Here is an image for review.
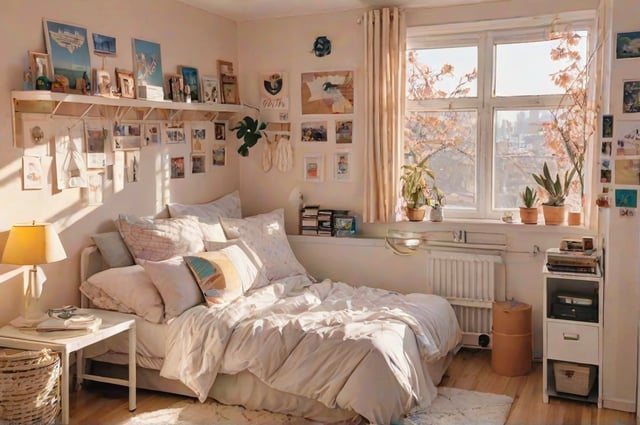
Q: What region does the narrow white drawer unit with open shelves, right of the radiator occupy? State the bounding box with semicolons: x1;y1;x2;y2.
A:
542;252;604;407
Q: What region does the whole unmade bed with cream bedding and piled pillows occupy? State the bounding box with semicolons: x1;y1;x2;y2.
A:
80;193;461;424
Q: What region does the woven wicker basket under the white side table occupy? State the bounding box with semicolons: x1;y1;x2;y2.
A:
0;349;60;425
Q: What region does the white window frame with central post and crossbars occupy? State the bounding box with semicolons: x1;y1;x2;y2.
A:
403;11;596;219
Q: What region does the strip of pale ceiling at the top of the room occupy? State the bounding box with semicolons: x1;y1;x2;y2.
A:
179;0;496;22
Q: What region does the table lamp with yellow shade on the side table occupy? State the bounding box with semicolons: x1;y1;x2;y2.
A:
2;221;67;320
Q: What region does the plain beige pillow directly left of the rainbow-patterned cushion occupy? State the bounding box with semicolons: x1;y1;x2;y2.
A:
141;256;203;321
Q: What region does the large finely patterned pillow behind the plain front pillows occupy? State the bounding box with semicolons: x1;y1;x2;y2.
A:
116;214;204;261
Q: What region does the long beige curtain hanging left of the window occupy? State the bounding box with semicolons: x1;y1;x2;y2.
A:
363;8;406;223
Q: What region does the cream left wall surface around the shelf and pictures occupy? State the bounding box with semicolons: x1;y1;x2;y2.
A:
0;0;238;324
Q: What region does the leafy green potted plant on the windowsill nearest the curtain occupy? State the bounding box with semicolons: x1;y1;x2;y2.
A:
400;158;434;221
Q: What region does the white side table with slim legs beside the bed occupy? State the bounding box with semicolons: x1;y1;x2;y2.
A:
0;309;136;425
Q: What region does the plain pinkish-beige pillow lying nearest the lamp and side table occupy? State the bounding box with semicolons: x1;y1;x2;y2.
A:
80;264;164;323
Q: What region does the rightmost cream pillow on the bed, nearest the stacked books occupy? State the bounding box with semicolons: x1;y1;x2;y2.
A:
220;208;307;281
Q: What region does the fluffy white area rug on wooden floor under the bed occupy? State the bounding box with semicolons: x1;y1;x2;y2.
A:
127;387;513;425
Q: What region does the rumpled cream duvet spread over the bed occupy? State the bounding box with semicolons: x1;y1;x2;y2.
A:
160;276;461;424
